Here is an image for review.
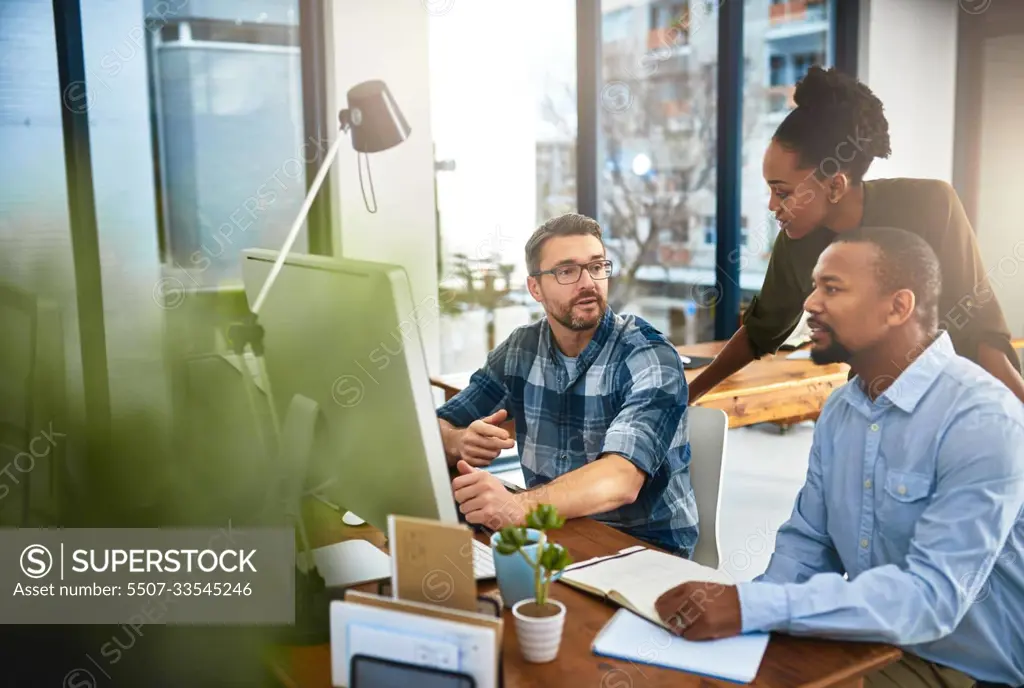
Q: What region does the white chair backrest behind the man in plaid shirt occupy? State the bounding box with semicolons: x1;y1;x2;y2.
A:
687;406;729;568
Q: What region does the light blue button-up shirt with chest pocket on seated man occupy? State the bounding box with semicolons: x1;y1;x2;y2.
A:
737;332;1024;686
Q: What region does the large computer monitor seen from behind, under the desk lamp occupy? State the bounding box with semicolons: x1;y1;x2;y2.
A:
243;249;459;532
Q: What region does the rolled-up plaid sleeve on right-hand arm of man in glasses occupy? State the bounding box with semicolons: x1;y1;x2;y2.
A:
601;344;689;476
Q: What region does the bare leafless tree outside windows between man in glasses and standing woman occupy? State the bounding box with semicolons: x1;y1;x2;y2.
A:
542;38;766;308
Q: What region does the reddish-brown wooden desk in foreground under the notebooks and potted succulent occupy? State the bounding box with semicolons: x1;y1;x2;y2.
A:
270;519;902;688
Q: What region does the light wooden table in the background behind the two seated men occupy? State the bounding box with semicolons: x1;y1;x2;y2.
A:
430;342;850;428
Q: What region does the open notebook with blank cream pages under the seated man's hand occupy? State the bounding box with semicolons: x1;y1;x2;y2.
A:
559;546;734;630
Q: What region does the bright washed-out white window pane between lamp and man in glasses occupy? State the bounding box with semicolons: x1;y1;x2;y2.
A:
430;0;581;373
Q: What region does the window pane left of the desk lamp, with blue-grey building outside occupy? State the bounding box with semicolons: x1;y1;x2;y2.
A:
124;0;307;290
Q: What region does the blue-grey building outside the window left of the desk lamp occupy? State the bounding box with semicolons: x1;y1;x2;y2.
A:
146;0;307;289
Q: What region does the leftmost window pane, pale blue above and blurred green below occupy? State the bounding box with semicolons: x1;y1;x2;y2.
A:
0;0;85;528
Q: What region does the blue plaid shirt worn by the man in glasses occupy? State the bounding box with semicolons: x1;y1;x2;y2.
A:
437;308;697;557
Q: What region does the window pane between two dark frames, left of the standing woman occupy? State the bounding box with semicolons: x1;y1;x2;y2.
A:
598;0;718;332
